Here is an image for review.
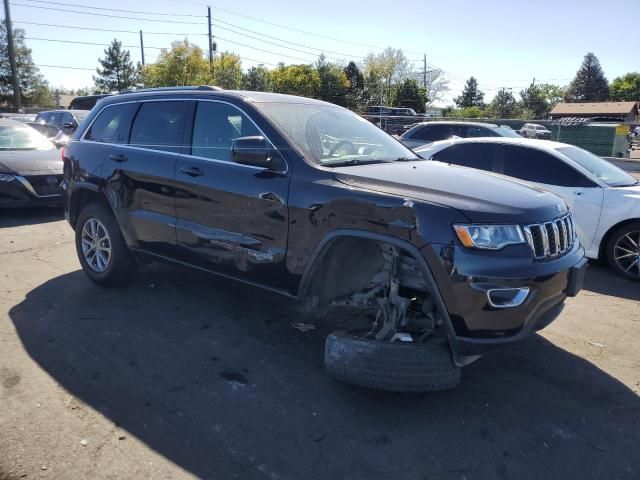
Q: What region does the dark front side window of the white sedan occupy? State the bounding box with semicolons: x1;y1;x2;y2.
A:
504;146;594;187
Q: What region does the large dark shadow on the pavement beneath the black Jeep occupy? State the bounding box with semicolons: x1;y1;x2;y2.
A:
10;265;640;479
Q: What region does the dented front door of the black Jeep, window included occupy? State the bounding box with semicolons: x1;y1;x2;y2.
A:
175;101;289;286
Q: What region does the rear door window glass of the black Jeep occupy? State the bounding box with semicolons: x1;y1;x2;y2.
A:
129;102;189;153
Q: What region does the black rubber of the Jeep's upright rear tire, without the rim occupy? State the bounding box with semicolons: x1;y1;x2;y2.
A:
75;203;137;286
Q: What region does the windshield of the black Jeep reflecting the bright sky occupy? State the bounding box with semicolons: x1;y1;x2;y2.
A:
256;103;420;167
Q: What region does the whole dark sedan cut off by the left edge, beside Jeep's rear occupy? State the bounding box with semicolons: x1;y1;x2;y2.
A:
0;119;62;208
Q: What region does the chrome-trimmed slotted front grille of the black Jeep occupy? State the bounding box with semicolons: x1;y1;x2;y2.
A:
524;214;576;260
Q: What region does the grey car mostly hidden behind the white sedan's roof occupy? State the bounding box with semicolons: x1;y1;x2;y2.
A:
399;121;520;148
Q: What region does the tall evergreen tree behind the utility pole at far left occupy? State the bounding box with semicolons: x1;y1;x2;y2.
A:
0;22;49;107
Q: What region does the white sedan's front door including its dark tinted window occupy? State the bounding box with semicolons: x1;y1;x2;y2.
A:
504;145;604;248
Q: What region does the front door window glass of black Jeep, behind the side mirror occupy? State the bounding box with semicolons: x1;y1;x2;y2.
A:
191;102;260;161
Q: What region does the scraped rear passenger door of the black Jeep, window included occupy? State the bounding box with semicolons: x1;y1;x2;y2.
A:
103;100;193;257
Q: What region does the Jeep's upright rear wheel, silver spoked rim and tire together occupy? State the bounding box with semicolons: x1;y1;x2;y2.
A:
76;203;136;286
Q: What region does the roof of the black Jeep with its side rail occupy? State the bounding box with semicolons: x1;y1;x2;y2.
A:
105;86;341;108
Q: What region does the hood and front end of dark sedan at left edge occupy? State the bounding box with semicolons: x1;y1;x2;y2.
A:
0;148;63;208
